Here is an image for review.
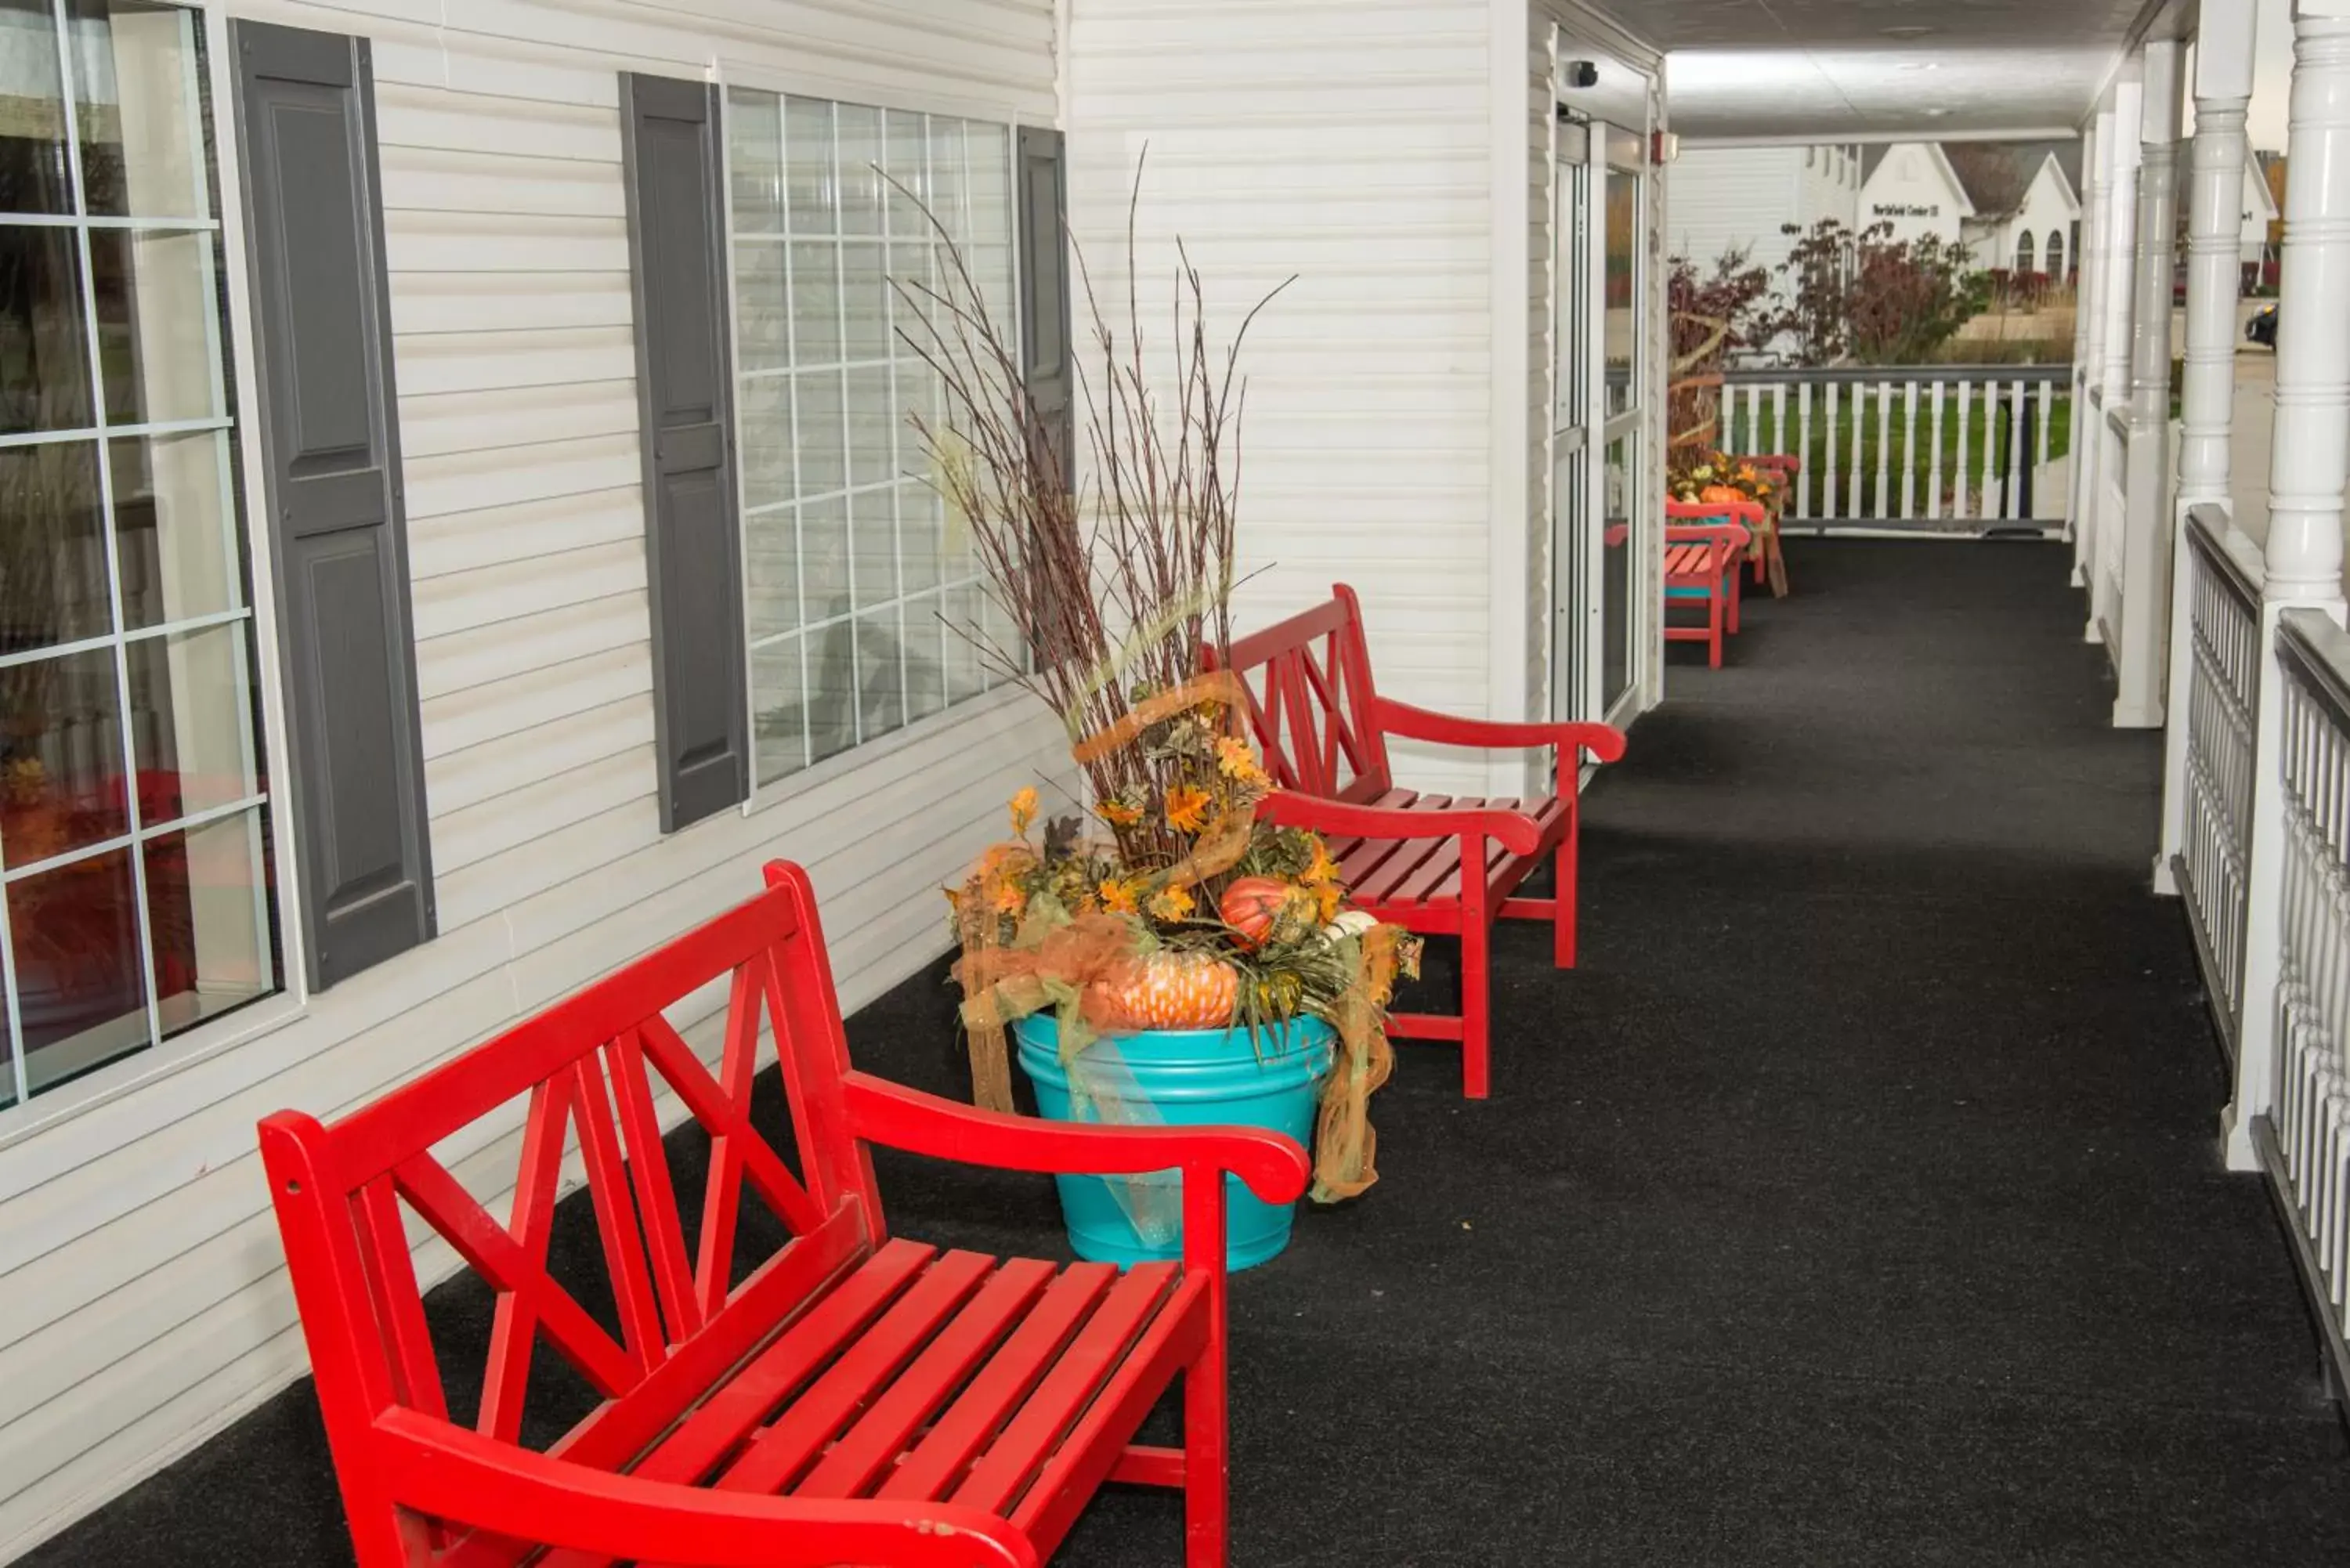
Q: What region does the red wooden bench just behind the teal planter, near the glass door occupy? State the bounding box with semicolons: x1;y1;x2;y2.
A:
1208;583;1624;1100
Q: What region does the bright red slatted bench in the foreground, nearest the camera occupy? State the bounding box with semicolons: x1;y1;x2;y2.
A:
261;865;1307;1568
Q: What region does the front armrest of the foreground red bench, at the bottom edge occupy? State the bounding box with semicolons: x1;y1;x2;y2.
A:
369;1408;1036;1568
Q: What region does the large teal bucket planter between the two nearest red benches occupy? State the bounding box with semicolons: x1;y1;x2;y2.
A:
1013;1013;1337;1270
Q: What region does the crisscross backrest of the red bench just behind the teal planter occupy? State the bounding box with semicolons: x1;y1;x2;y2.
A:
1208;583;1394;802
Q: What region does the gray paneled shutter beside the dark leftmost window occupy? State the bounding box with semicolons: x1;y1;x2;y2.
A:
235;21;435;990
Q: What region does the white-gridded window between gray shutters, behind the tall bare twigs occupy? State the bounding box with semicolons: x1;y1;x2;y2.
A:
726;89;1018;782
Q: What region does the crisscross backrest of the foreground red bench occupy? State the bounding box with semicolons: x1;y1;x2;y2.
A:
261;865;881;1483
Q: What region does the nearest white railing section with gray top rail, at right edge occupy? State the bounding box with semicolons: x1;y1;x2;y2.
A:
2256;609;2350;1400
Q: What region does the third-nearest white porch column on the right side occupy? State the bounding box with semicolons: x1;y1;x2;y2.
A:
2113;38;2181;728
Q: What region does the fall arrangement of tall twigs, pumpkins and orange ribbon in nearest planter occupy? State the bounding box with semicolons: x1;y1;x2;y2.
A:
898;162;1417;1199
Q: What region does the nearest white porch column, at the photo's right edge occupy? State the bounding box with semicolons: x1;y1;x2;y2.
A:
2221;0;2350;1171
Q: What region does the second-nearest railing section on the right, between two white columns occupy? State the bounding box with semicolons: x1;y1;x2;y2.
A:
2171;508;2261;1056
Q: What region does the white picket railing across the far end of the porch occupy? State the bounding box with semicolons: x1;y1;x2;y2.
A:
1723;364;2070;531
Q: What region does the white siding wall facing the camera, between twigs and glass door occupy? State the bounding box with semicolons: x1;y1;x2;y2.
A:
1067;0;1485;793
